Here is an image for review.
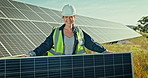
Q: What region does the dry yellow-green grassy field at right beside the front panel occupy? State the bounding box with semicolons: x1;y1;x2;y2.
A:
88;34;148;78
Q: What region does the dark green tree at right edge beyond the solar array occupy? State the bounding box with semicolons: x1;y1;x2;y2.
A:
133;16;148;33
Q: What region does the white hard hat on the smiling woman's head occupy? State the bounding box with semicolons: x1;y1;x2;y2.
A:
62;4;76;16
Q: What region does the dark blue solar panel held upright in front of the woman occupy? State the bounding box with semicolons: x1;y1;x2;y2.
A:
0;53;134;78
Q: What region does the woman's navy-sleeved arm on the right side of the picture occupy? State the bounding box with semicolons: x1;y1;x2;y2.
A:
83;31;106;53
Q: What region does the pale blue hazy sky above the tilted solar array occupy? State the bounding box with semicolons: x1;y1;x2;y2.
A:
16;0;148;25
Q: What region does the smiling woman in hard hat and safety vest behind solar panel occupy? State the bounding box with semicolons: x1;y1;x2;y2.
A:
26;4;108;56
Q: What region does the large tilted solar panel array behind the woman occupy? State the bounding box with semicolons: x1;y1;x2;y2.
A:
0;0;141;57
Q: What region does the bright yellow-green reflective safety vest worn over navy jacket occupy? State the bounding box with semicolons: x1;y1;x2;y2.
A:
48;27;86;56
